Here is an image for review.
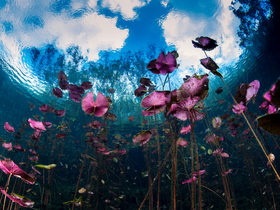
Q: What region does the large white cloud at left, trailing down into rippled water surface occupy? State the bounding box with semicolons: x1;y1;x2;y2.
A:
0;1;129;92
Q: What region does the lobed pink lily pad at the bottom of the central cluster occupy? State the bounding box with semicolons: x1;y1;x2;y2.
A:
167;96;205;121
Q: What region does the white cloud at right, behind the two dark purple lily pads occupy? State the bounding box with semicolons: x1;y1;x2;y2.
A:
160;0;241;76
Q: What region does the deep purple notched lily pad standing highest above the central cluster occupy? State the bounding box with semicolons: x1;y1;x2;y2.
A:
156;52;177;75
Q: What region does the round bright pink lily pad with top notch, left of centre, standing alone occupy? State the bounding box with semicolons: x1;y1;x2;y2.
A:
82;92;109;117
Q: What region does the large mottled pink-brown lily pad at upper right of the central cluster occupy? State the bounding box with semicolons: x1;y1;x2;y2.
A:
176;74;209;101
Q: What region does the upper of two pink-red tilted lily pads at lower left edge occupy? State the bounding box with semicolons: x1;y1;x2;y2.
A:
0;160;35;184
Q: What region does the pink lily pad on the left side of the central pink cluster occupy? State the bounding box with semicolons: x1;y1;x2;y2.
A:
141;91;171;116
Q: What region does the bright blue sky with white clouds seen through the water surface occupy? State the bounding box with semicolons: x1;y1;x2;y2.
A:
0;0;242;94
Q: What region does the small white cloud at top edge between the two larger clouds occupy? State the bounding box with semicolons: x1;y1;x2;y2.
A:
102;0;146;20
